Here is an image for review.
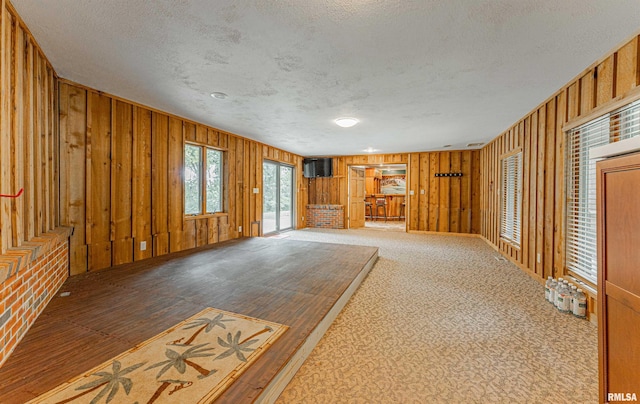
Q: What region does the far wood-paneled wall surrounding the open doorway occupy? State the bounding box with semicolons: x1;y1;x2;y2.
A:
307;150;480;233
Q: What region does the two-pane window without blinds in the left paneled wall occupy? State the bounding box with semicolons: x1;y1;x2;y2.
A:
184;144;223;215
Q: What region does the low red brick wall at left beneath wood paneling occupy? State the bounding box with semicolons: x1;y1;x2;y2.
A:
0;231;69;366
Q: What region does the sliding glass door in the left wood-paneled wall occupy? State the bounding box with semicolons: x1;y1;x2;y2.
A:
262;161;295;234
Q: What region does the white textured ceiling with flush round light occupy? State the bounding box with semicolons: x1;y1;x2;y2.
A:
13;0;640;156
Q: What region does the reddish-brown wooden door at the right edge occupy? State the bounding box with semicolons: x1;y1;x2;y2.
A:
597;154;640;402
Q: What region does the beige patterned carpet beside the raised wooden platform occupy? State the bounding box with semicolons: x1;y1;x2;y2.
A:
278;229;598;403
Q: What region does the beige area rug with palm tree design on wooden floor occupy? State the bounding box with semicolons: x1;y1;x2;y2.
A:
30;308;288;404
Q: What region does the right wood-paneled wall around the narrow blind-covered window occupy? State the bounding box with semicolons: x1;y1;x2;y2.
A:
481;37;640;280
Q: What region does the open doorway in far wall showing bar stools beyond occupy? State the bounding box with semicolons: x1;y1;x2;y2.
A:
349;164;408;231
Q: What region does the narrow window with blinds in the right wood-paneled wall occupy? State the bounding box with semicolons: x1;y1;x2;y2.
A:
500;152;522;246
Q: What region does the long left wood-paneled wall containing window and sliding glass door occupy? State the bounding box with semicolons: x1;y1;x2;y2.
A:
59;81;307;274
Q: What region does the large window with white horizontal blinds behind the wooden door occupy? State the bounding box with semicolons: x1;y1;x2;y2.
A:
565;101;640;284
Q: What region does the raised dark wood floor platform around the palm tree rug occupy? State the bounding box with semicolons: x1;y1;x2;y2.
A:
0;238;378;403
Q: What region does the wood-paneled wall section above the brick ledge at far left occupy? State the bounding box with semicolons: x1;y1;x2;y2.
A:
0;1;59;255
